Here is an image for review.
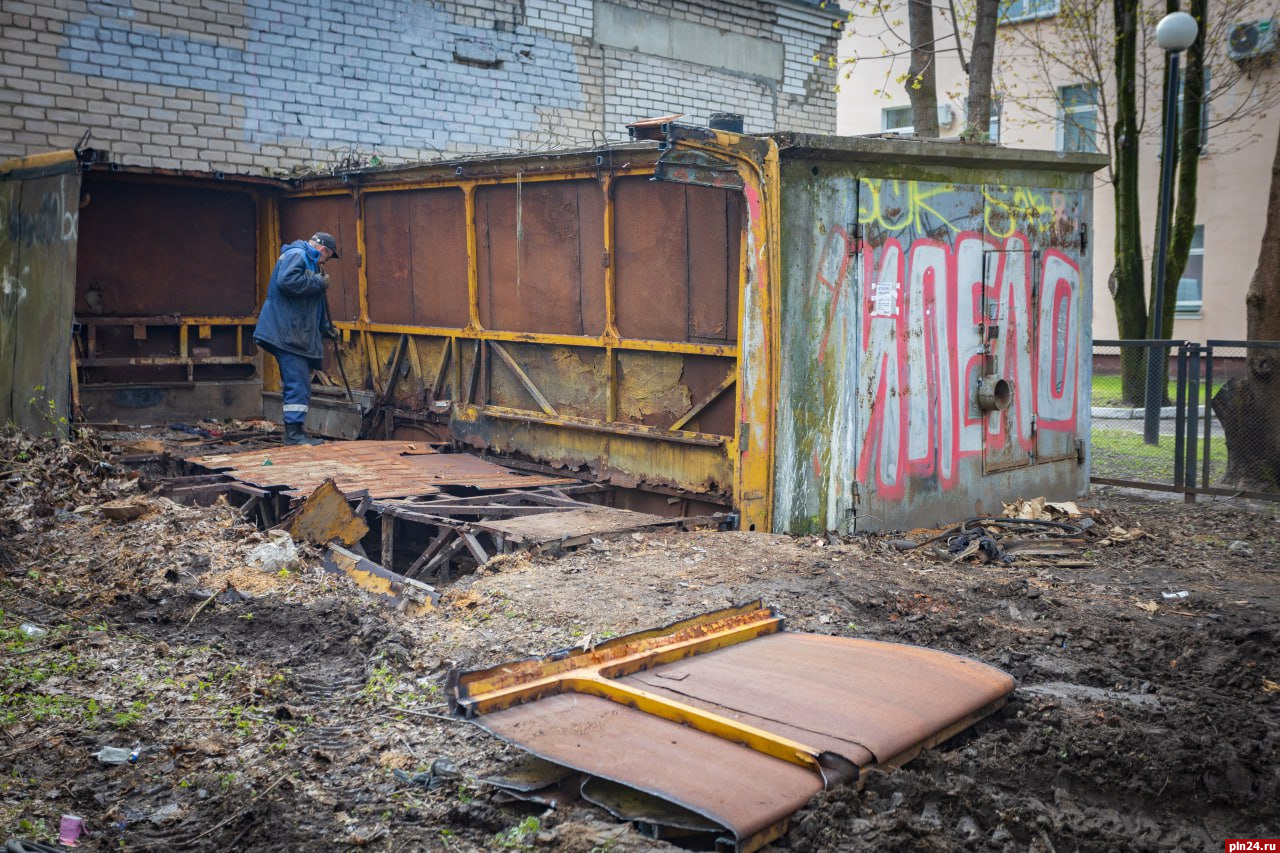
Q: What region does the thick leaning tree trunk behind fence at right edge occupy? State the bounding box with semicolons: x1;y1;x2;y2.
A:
1213;122;1280;492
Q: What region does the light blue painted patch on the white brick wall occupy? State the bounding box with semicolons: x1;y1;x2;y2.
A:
59;0;585;150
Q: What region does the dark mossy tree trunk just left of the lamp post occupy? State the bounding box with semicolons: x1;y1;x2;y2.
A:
1111;0;1147;405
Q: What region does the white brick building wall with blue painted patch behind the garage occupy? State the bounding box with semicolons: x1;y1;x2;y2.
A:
0;0;840;174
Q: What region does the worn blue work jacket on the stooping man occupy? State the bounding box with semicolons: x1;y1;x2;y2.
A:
253;240;328;368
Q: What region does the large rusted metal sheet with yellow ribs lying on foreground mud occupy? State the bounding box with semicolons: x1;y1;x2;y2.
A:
448;602;1014;850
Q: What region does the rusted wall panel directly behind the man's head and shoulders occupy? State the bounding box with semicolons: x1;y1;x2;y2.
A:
279;192;361;321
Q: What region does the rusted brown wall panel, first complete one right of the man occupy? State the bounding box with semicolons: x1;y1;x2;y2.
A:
364;187;468;329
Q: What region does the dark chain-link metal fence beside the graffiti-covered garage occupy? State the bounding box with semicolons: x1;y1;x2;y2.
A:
1089;341;1280;501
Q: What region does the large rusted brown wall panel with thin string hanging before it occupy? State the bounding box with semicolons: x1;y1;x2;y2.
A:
476;181;604;336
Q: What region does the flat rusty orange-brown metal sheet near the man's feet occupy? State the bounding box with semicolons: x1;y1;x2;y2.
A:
187;442;579;500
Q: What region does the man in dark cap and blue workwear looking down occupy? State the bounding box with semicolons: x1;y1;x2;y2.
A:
253;231;338;444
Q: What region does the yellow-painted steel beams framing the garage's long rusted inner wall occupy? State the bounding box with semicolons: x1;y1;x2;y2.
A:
272;132;781;530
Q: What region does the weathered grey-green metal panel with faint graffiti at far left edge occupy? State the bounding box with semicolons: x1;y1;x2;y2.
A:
0;151;81;434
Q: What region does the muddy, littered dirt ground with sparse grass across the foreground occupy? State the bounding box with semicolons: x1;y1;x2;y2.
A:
0;433;1280;853
